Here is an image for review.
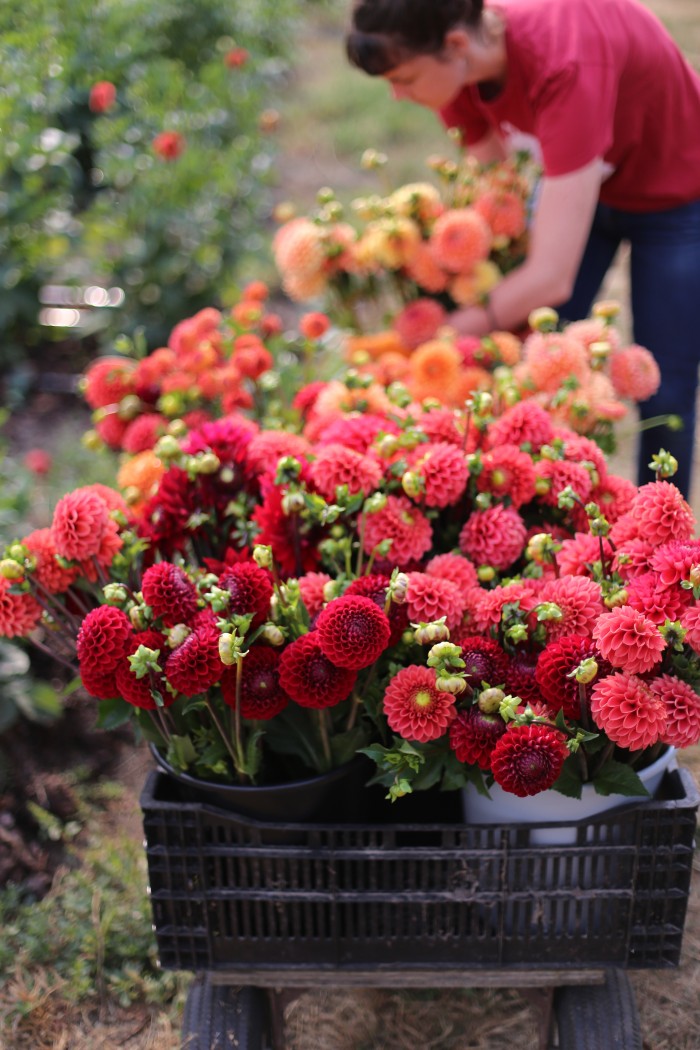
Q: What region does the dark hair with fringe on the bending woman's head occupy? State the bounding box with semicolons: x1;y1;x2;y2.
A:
345;0;484;77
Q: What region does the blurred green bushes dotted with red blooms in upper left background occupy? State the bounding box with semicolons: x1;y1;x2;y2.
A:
0;0;304;368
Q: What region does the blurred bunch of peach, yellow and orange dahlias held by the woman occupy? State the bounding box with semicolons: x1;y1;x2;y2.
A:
273;143;539;332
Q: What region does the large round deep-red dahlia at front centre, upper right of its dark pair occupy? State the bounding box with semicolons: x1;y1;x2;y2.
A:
316;594;390;671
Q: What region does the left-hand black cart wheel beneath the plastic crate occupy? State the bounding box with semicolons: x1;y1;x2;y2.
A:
182;973;272;1050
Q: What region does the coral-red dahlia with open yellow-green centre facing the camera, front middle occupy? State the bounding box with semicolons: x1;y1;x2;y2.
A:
383;664;455;743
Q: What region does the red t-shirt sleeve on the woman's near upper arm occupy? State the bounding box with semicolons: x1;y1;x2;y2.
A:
532;63;617;175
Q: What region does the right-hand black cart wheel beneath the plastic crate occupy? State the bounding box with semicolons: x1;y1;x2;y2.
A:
554;969;642;1050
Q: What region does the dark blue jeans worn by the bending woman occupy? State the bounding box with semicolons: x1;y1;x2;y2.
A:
557;201;700;498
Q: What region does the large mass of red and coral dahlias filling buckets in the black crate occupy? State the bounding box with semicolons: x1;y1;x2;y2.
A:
0;298;700;818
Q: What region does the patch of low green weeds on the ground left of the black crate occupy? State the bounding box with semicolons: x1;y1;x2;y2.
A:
0;818;182;1027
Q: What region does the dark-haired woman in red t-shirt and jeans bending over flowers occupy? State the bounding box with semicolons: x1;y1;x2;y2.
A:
346;0;700;495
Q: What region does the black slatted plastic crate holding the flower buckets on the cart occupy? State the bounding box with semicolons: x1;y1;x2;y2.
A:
141;769;700;972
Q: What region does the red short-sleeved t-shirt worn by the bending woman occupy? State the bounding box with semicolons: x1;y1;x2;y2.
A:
441;0;700;211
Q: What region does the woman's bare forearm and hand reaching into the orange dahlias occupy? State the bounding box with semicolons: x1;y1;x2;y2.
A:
449;159;602;335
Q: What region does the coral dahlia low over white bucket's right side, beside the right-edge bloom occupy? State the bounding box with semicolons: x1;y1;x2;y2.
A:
591;674;667;751
